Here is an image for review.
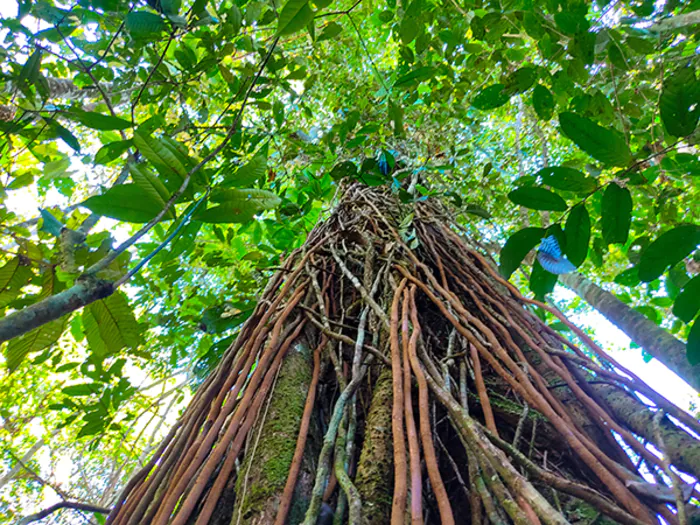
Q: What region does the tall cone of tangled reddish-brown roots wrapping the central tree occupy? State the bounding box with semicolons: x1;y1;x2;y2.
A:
108;185;700;525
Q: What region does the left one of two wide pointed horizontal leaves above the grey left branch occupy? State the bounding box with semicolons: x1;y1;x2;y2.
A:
82;184;163;223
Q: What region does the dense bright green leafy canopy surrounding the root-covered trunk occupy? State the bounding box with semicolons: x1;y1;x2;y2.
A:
0;0;700;519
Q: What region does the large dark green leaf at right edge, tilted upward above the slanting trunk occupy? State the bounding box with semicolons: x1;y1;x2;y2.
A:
639;224;700;283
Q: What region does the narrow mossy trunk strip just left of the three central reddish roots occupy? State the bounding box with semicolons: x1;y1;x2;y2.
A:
355;368;394;525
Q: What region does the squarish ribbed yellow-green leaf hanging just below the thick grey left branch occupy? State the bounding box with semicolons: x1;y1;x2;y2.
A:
82;291;141;358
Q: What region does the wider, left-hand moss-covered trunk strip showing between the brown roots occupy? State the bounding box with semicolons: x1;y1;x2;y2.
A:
231;344;319;525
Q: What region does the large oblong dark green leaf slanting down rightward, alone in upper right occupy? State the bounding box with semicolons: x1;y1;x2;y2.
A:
559;113;632;167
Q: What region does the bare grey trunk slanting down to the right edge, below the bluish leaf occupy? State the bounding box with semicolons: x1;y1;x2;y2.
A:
560;273;700;390
